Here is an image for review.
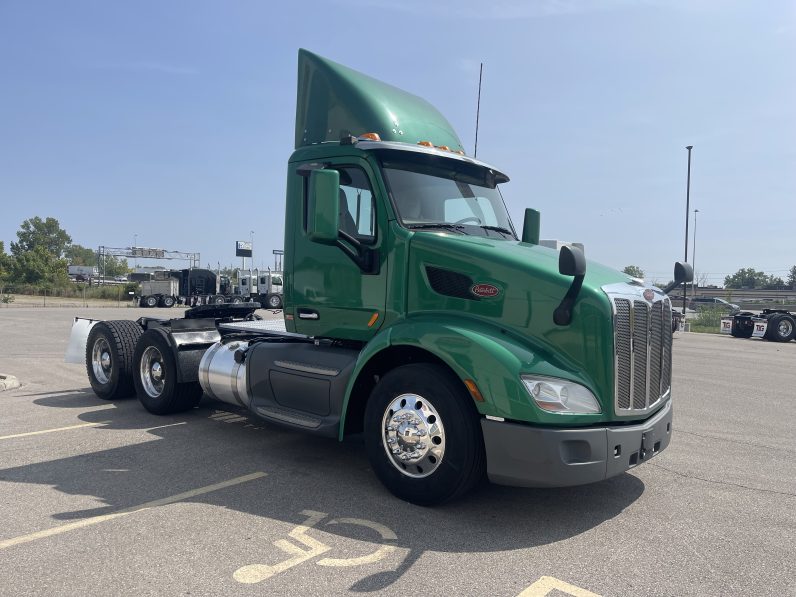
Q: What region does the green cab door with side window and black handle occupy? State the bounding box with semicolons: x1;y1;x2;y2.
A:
285;159;387;340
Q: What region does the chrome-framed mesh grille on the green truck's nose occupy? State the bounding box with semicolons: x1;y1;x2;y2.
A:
605;285;672;415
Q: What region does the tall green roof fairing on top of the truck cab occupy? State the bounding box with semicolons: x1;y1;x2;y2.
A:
296;50;464;151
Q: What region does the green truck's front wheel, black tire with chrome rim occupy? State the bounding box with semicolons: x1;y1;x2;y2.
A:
365;363;486;506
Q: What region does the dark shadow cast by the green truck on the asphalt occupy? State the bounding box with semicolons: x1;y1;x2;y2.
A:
0;393;644;592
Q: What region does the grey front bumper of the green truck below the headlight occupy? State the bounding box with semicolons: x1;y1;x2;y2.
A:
481;399;672;487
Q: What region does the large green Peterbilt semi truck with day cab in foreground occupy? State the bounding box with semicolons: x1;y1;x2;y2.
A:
70;50;692;504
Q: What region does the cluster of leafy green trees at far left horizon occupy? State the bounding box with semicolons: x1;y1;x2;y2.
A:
0;216;130;288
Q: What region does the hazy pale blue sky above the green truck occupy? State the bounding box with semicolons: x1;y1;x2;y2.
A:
0;0;796;283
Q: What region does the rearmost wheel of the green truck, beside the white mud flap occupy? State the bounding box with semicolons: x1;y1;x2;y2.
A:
86;321;143;400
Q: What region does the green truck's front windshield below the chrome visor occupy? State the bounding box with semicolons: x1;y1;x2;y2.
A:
383;163;516;239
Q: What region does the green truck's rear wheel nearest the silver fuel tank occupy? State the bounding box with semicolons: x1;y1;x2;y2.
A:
133;329;202;415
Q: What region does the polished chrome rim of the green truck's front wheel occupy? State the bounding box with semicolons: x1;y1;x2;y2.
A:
382;394;445;479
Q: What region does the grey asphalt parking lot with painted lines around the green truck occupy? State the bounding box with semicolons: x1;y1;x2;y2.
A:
0;308;796;597
